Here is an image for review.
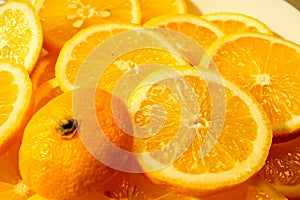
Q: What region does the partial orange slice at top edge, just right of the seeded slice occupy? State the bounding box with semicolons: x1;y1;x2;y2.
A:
139;0;187;24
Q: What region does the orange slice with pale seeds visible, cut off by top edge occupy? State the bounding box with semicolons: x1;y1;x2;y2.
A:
35;0;141;51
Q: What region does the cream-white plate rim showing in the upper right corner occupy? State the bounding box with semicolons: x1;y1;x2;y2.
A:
187;0;300;44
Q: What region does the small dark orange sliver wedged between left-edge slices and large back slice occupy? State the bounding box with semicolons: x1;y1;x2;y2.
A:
30;53;57;91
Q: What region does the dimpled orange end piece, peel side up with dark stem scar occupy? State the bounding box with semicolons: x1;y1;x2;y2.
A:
19;90;133;200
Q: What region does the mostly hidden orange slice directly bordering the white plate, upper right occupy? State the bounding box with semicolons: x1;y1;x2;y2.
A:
201;12;273;35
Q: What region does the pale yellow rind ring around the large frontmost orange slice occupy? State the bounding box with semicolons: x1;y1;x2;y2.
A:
129;70;272;195
